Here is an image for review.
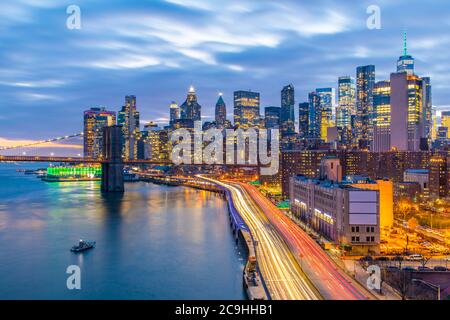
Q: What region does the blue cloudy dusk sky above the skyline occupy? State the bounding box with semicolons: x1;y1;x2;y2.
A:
0;0;450;140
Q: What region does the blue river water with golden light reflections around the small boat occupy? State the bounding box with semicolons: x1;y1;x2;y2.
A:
0;163;245;299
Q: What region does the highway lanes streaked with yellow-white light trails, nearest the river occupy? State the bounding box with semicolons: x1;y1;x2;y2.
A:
203;177;323;300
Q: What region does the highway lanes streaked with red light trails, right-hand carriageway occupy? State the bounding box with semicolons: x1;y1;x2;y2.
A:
240;183;373;300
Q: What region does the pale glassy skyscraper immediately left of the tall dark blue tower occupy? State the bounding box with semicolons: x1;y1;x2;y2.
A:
336;76;356;129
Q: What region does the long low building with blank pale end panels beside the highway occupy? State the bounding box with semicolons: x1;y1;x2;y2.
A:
289;158;380;255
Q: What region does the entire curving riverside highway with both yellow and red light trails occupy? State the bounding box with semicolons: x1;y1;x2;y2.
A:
202;176;374;300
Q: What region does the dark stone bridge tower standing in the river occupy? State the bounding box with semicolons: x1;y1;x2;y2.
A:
102;126;124;192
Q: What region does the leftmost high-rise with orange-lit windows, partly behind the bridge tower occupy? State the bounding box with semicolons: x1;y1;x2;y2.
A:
83;108;116;159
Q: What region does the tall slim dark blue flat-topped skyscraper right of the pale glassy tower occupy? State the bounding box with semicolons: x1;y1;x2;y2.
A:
356;65;375;150
